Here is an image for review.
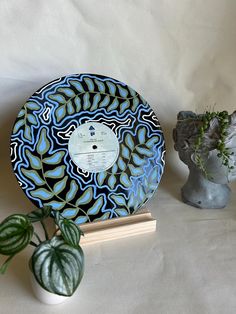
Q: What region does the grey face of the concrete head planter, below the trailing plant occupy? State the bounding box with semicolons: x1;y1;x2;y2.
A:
205;137;236;184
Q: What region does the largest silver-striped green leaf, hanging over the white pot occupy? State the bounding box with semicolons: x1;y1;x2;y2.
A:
32;236;84;296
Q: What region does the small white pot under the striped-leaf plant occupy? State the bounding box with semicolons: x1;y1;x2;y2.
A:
30;273;70;305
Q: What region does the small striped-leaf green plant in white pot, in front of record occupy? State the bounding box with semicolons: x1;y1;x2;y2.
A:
0;206;84;304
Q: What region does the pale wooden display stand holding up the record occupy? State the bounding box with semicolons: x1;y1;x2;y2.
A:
80;210;156;246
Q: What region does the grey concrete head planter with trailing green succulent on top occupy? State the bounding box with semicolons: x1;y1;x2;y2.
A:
173;111;236;208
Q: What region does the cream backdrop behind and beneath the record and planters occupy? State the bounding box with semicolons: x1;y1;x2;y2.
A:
0;0;236;314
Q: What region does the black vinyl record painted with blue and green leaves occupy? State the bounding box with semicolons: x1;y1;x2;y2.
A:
11;74;165;224
